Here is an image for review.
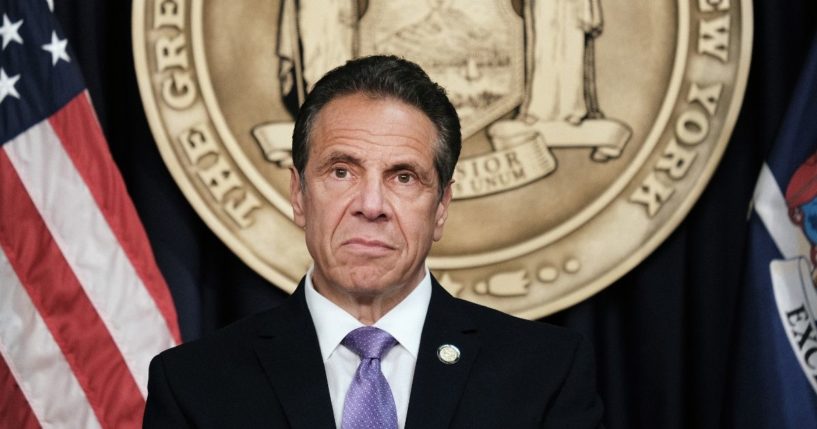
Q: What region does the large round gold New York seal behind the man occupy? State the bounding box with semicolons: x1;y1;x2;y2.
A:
133;0;752;318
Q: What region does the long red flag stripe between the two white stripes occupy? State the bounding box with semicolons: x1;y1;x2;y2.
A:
0;151;144;428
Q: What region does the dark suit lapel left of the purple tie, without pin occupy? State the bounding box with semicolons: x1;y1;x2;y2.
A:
254;281;335;429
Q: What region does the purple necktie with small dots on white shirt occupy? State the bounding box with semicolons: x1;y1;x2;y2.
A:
340;326;397;429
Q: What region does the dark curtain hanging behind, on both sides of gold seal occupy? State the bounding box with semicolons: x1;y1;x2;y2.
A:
55;0;817;428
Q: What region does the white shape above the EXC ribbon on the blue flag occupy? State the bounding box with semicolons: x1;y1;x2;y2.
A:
754;163;811;264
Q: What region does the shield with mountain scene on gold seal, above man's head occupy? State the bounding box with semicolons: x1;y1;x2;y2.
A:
358;0;525;138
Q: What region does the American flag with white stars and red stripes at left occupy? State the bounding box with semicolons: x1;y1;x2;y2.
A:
0;0;180;428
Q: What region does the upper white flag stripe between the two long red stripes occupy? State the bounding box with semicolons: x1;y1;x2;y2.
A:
4;121;174;397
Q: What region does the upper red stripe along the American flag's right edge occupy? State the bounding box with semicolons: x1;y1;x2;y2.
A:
49;92;181;343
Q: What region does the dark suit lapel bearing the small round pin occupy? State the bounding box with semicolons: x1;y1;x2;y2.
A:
406;277;479;428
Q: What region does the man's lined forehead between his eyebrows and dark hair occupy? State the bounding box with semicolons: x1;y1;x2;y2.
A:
310;93;437;157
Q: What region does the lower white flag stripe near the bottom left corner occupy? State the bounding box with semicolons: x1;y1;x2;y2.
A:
0;244;101;428
